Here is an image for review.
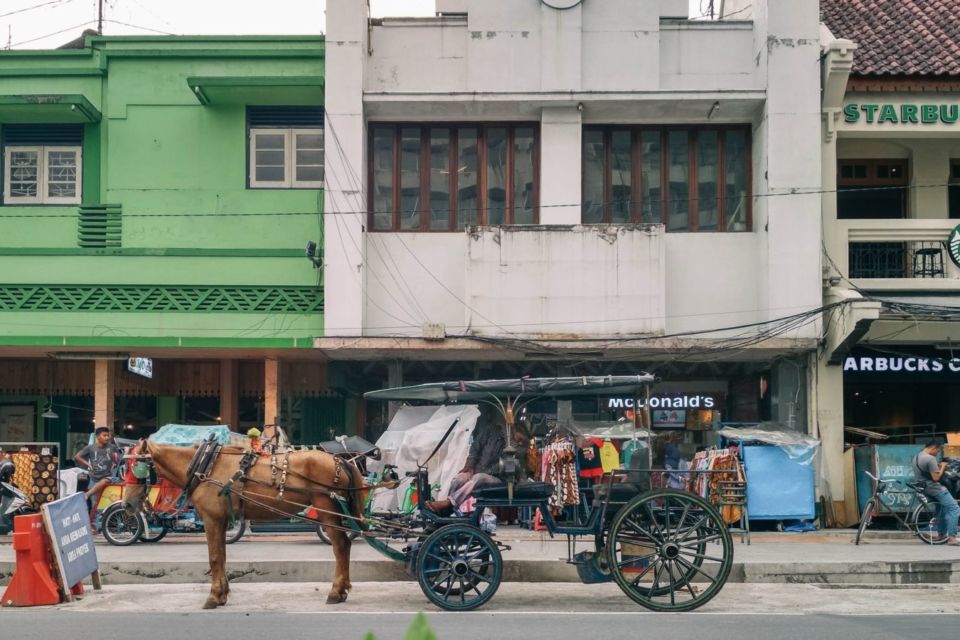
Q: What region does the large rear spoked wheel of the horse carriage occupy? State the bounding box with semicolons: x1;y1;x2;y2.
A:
607;489;733;611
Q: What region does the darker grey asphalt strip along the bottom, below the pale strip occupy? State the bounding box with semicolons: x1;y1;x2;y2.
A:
0;610;960;640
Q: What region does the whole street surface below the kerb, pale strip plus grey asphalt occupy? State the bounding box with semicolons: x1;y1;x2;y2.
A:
0;582;960;640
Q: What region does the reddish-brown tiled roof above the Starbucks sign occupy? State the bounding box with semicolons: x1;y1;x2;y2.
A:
820;0;960;76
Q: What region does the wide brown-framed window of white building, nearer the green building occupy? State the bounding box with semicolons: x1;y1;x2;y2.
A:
369;123;539;231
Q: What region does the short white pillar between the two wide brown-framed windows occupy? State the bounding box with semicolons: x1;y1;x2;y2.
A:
540;106;583;224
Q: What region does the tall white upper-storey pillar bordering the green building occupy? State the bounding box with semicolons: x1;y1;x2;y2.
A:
323;0;369;336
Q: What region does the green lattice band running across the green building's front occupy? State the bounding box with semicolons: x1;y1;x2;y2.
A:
0;285;323;313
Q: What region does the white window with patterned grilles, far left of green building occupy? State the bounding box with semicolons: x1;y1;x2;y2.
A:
3;124;83;205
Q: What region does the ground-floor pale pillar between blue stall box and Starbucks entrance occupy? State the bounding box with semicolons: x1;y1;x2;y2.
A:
814;354;844;504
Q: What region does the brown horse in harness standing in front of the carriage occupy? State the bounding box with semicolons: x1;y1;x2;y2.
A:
123;440;366;609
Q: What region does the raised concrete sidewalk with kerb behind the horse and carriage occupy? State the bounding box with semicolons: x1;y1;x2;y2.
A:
0;527;960;584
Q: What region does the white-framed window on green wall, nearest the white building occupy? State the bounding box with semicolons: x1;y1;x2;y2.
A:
247;107;323;189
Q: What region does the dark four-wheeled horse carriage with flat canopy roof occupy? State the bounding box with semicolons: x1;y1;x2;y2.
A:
343;375;733;612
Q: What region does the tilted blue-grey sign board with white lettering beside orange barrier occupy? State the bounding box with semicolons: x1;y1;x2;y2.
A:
41;493;99;591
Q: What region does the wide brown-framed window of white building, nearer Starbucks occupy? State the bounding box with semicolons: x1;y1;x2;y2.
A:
581;127;750;231
